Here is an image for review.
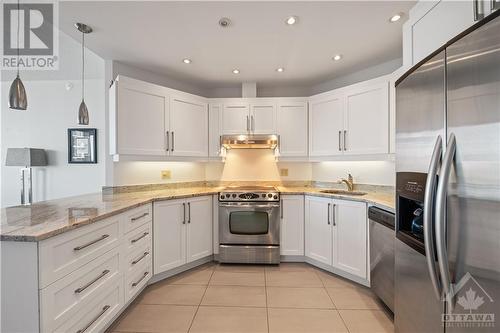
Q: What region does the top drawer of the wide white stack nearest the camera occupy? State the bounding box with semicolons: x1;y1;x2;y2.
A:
39;217;120;289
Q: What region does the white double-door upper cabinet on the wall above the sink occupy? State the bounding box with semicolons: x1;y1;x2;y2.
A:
309;77;389;158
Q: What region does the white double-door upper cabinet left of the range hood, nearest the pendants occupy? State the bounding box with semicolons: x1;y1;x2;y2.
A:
110;76;208;157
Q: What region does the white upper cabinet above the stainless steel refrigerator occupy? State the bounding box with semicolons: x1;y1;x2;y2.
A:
403;0;500;68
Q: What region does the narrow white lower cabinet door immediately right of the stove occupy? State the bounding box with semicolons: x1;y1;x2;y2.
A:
280;195;304;256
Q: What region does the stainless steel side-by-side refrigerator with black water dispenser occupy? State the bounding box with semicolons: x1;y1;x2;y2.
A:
394;13;500;333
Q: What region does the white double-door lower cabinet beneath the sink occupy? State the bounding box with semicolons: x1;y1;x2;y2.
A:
305;197;367;279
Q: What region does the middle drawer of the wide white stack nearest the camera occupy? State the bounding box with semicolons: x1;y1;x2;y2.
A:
40;248;120;328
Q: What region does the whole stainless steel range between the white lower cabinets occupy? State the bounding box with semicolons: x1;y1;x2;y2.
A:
219;186;280;264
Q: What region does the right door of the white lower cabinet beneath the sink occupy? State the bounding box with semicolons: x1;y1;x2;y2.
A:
333;200;368;279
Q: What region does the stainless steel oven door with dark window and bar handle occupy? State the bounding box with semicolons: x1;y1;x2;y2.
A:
219;202;280;245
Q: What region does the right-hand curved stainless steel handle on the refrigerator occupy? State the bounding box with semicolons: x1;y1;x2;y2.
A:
435;133;456;297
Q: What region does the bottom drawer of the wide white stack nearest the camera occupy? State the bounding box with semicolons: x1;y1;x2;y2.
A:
52;276;123;333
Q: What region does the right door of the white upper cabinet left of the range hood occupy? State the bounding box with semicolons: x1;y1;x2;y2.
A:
170;97;208;156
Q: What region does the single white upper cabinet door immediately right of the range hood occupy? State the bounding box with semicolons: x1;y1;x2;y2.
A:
277;101;307;156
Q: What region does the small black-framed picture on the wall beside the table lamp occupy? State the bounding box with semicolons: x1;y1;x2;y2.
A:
68;128;97;163
